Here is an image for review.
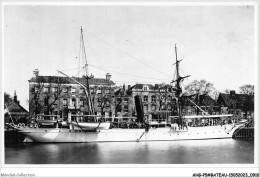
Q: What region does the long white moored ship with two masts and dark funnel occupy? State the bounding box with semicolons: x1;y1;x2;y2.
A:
6;29;244;142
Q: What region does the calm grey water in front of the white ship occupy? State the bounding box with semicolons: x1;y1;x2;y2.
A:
5;139;254;164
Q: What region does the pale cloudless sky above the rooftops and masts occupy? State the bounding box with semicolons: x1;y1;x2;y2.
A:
2;5;256;109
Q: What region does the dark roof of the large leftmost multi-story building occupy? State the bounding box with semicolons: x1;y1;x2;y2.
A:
29;76;115;85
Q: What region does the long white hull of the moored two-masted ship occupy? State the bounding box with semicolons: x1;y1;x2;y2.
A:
13;125;242;143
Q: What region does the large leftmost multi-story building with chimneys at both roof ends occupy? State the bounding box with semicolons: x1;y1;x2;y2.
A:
29;70;115;120
